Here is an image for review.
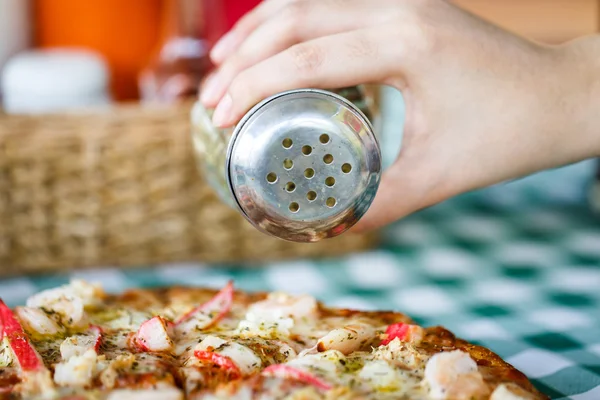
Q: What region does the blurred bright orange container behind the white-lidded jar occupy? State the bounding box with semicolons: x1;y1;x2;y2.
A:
34;0;163;100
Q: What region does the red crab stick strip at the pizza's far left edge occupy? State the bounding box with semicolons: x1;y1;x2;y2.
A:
0;299;45;372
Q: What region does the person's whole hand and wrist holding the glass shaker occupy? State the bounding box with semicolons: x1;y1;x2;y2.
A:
201;0;600;229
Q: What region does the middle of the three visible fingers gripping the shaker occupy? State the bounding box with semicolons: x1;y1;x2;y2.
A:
201;1;380;108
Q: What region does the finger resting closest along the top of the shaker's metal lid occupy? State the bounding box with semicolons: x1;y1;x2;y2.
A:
213;30;393;127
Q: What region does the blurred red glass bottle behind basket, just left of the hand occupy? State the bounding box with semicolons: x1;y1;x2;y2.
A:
140;0;226;103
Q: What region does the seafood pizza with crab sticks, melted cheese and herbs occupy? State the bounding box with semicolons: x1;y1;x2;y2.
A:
0;280;547;400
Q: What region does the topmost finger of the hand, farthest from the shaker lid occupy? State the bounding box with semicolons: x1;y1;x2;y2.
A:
210;0;293;65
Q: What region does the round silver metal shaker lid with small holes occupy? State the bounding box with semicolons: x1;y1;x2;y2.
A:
226;89;381;242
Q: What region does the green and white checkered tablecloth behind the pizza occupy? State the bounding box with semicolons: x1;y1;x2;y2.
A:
0;163;600;400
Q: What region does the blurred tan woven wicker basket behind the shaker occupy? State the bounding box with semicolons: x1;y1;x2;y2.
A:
0;101;375;276
